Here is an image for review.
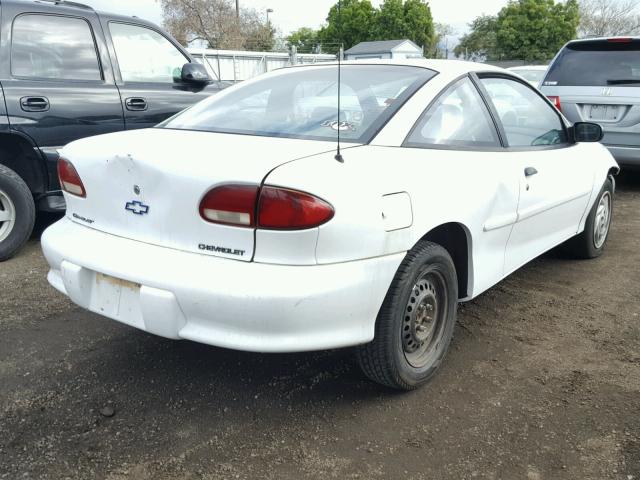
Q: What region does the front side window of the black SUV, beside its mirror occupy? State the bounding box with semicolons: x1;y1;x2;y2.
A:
109;22;189;83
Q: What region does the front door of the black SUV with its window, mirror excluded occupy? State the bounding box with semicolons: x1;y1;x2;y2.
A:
106;21;219;130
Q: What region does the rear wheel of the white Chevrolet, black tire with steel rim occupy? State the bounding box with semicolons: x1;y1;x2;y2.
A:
356;241;458;390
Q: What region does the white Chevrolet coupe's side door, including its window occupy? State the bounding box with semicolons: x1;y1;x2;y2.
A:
480;75;593;273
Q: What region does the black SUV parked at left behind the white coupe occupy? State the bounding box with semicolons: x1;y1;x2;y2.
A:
0;0;224;261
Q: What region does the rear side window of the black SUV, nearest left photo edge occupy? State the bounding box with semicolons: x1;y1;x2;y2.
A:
11;14;102;81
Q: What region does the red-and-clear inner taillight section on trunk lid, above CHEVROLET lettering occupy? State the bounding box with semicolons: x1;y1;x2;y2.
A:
200;185;260;227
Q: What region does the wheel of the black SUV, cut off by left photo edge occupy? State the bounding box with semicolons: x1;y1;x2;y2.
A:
0;165;36;262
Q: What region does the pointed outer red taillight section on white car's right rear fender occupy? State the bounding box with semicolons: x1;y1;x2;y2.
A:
258;187;334;230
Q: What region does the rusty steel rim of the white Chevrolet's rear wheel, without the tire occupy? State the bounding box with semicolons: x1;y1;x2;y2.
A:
401;271;448;368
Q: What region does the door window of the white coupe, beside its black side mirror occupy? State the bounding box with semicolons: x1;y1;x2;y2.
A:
482;78;567;147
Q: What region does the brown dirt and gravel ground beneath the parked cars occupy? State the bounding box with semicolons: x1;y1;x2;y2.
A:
0;175;640;480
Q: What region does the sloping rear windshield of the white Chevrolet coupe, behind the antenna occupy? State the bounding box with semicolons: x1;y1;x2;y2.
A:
159;65;436;143
